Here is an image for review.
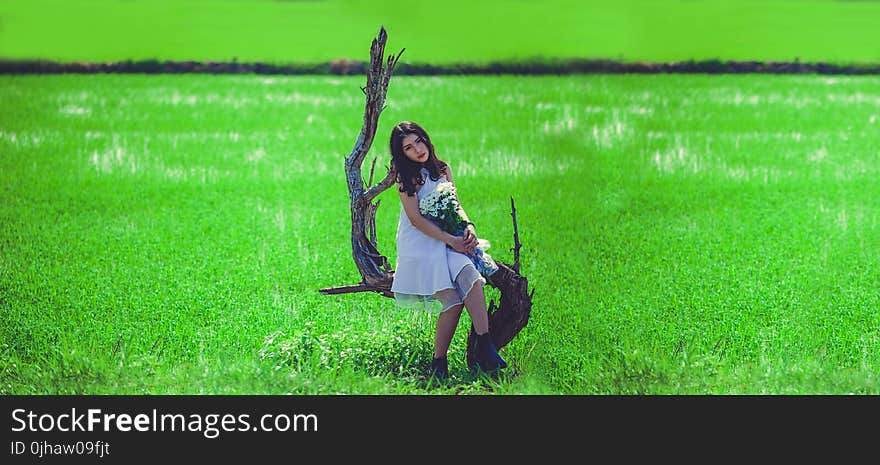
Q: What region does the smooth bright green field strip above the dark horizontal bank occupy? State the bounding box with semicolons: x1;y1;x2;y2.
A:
0;0;880;64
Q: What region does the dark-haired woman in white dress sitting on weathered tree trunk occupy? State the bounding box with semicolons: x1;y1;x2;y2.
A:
390;121;507;379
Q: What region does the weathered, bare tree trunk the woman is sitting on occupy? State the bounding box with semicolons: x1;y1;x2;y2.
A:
320;27;534;365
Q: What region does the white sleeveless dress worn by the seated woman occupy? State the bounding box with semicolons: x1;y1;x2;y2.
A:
391;168;486;313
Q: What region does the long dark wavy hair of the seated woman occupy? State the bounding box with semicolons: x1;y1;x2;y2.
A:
389;121;446;197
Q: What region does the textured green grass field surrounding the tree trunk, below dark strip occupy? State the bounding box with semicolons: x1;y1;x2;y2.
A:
0;75;880;394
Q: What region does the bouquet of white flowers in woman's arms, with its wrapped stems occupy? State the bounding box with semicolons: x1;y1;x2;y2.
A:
419;181;498;278
